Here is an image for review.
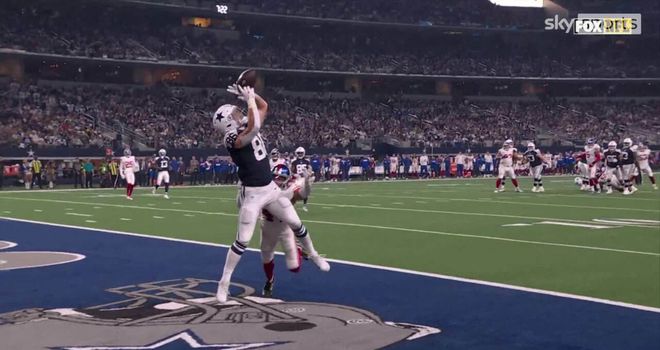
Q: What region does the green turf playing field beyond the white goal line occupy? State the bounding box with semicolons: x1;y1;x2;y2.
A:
0;177;660;307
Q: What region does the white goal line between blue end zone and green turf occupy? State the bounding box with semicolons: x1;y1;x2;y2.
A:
0;217;660;313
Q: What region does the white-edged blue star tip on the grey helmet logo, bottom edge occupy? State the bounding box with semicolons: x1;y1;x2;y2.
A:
56;330;287;350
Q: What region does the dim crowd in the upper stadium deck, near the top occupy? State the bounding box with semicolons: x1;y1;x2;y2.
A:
0;1;660;77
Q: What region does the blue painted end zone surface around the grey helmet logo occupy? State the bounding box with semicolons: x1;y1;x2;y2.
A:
0;220;660;350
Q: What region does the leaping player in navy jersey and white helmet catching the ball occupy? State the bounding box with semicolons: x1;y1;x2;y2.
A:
213;85;330;303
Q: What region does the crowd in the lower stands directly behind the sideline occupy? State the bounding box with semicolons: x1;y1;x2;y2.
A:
0;82;660;149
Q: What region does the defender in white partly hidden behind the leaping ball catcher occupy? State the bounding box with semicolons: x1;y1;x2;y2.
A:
261;165;330;297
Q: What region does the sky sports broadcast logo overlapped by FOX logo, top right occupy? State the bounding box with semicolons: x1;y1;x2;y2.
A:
545;13;642;35
